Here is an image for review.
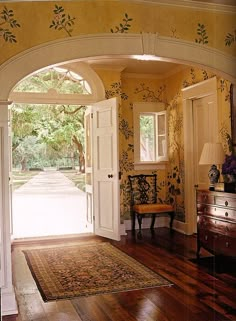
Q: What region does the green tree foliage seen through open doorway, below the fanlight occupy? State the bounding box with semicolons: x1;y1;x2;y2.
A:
12;104;85;168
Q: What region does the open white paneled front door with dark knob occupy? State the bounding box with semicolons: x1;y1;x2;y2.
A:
93;98;120;241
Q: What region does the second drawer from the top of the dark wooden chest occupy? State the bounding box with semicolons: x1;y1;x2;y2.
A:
197;204;236;223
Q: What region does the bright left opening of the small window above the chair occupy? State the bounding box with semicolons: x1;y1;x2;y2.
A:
140;115;155;161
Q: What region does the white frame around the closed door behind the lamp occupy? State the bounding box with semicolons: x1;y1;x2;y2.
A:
182;77;218;235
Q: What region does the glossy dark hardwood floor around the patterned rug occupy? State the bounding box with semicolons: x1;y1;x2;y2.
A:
3;228;236;321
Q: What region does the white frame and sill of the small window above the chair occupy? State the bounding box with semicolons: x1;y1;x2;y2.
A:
133;102;168;170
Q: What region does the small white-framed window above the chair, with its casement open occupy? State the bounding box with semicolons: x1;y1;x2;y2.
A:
133;103;168;169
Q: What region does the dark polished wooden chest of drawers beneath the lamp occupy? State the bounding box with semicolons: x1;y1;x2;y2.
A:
196;190;236;257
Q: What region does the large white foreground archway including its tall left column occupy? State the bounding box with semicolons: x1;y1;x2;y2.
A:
0;34;236;314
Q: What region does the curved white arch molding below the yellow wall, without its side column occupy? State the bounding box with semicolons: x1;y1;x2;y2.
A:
0;33;236;100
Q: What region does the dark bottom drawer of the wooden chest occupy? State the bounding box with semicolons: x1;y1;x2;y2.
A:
198;229;236;257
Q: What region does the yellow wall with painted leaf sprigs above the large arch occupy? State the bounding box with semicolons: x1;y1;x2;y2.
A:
0;0;236;64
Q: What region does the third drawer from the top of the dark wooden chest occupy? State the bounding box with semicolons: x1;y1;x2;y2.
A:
197;215;236;238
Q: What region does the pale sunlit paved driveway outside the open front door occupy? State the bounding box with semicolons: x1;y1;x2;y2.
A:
12;170;92;238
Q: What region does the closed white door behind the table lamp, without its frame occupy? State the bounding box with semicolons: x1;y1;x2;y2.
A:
193;94;218;189
